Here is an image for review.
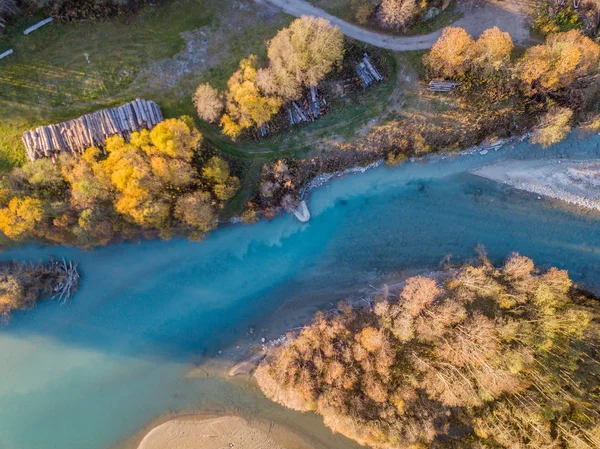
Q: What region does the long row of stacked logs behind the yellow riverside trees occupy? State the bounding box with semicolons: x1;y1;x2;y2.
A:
23;98;163;162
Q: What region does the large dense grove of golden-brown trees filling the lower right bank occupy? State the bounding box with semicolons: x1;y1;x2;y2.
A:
256;254;600;449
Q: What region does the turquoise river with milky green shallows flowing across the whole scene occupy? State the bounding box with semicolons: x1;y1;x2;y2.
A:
0;136;600;449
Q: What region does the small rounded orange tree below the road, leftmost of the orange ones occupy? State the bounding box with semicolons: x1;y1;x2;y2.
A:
424;27;473;78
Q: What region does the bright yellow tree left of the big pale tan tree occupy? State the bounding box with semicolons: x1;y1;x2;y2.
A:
221;55;282;139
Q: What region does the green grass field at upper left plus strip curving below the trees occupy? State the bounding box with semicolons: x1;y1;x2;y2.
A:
0;0;404;170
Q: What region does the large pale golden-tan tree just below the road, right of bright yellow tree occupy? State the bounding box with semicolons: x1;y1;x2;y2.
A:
263;16;344;100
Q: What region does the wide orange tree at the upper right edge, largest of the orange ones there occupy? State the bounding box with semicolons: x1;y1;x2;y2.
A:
516;30;600;93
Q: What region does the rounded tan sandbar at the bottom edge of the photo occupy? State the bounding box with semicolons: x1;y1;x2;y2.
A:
138;416;311;449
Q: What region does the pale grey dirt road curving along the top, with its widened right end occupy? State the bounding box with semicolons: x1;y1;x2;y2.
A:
257;0;529;51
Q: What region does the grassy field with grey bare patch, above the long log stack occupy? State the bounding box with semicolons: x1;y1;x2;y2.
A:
0;0;289;170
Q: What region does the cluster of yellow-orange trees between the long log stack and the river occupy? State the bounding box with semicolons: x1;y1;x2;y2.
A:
0;119;239;247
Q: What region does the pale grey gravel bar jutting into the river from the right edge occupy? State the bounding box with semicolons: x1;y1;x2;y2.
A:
471;159;600;211
